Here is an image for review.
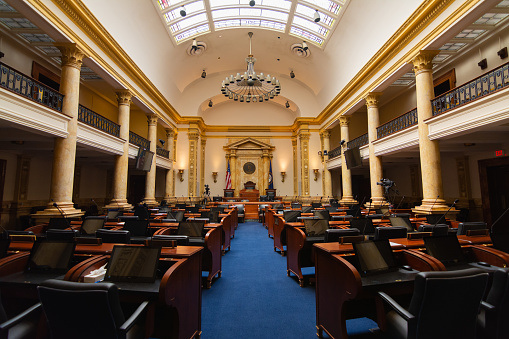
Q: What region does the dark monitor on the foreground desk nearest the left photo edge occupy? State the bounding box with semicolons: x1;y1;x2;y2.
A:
26;240;76;272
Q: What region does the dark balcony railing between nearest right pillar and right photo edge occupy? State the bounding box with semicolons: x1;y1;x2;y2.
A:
431;63;509;115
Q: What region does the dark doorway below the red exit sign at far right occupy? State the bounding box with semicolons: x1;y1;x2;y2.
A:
479;157;509;233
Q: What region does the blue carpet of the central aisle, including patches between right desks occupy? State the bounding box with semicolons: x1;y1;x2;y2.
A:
198;222;377;339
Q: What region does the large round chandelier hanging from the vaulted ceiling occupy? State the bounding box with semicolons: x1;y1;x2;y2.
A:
221;32;281;102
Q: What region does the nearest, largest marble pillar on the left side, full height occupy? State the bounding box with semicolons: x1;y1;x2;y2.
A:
34;43;85;218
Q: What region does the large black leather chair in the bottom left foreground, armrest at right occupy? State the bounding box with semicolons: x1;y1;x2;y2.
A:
37;279;148;339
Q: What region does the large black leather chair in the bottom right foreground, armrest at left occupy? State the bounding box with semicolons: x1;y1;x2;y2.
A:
378;268;488;339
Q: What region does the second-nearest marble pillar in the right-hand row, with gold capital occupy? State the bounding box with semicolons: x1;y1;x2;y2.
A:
366;92;385;208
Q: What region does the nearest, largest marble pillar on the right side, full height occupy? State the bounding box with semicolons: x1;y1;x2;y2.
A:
412;51;448;213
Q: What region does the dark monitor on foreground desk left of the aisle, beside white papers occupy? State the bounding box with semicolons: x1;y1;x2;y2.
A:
104;246;161;283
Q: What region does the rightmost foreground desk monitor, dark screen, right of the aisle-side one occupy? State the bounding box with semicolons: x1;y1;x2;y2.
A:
423;235;467;265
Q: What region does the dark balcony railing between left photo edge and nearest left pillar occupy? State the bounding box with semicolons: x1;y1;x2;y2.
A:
0;63;64;112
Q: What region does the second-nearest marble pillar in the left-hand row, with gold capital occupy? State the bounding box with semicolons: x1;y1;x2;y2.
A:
106;91;133;210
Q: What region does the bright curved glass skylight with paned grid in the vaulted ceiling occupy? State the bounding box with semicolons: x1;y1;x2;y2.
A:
153;0;348;46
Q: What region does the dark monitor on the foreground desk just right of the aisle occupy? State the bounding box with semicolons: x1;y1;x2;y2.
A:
352;239;398;275
